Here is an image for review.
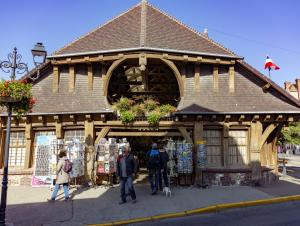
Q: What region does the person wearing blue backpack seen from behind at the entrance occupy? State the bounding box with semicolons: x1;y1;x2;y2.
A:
146;143;160;195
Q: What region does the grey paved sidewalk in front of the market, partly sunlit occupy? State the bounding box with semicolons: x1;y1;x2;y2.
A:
6;157;300;226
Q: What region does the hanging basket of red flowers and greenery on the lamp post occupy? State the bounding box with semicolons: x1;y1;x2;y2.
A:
0;80;36;117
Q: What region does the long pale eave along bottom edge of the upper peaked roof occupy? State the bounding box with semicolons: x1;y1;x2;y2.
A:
47;47;244;60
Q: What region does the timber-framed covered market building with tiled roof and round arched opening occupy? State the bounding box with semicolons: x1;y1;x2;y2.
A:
0;1;300;185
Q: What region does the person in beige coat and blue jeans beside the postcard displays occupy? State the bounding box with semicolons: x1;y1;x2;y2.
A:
48;151;70;201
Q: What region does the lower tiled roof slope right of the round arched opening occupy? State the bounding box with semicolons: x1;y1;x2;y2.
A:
178;61;300;114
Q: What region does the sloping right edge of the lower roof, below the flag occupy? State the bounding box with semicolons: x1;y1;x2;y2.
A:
238;60;300;107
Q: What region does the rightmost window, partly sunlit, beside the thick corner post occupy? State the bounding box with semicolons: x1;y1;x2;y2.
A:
228;130;248;166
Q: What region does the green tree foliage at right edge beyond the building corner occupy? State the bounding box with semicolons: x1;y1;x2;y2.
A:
278;122;300;145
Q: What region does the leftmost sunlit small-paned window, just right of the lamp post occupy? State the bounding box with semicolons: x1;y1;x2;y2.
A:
8;132;26;167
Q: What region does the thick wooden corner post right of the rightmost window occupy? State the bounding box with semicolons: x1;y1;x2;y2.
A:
250;121;263;185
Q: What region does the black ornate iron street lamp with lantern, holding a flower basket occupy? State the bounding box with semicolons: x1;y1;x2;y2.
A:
0;43;46;226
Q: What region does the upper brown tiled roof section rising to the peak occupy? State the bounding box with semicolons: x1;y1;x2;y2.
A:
50;3;236;57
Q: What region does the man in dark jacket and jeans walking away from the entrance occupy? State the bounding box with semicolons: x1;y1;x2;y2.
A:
117;146;136;204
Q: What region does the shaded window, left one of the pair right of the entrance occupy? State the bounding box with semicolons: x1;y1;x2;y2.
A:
203;130;223;167
